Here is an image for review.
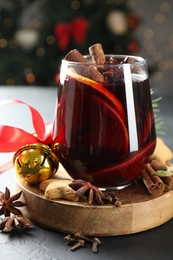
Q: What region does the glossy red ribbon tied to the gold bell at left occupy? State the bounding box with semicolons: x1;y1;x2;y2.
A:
0;99;64;173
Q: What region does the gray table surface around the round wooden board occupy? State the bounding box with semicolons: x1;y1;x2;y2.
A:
0;86;173;260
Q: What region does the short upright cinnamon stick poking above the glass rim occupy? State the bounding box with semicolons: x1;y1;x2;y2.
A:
89;43;106;64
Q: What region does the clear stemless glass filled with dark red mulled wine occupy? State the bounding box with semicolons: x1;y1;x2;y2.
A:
53;55;156;189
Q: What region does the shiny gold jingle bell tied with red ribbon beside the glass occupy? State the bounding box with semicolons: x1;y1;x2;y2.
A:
13;143;59;184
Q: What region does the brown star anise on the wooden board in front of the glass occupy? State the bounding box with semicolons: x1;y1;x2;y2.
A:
69;180;107;205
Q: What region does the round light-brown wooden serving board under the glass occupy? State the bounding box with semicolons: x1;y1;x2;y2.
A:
15;166;173;236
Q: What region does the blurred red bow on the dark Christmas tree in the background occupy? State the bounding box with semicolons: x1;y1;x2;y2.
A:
54;17;88;51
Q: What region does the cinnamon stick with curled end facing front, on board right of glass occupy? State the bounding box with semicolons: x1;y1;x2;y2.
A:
141;169;165;195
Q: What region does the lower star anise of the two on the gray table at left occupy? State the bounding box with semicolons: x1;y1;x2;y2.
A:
0;215;32;233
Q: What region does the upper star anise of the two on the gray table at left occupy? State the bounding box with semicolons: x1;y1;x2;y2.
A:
0;187;25;217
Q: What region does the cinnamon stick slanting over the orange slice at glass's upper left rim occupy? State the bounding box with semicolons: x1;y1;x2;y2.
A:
64;49;104;83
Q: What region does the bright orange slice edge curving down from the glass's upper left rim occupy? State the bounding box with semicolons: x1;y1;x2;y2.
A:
66;68;125;120
